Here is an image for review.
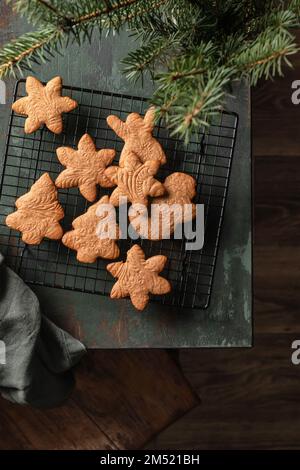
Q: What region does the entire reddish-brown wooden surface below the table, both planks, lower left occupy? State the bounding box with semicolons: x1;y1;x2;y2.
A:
0;351;199;450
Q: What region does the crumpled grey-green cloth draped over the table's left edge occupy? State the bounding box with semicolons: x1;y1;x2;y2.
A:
0;254;85;408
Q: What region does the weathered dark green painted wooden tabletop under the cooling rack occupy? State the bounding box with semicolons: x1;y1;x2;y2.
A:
0;7;252;348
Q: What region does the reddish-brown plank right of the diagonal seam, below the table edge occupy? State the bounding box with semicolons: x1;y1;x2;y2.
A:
74;350;199;449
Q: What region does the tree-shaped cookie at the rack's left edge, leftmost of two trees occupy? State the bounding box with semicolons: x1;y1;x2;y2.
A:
5;173;64;245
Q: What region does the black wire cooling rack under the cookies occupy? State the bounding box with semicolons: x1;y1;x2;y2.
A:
0;80;238;308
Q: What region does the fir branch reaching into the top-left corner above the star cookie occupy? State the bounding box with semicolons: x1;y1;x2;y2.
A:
0;0;168;77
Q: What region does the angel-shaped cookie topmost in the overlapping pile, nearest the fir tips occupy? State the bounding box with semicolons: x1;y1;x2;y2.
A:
107;107;167;167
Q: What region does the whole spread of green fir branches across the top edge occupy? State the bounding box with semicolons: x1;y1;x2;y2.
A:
0;0;300;139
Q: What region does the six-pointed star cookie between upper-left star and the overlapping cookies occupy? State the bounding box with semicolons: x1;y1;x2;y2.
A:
55;134;115;202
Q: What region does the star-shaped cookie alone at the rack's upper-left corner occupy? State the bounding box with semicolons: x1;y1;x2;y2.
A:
12;77;78;134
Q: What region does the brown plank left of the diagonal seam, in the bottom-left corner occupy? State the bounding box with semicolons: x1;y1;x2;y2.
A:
0;399;116;450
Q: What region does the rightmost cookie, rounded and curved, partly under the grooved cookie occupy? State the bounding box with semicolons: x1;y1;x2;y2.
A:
129;173;196;240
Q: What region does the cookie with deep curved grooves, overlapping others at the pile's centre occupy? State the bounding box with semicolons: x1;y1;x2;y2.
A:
105;152;165;206
